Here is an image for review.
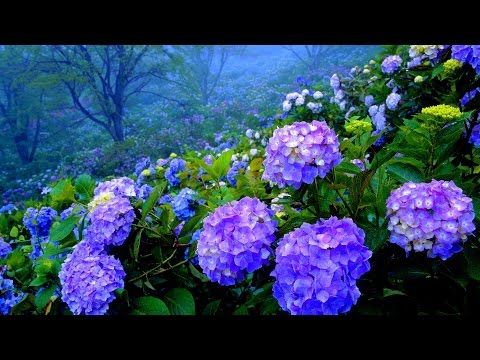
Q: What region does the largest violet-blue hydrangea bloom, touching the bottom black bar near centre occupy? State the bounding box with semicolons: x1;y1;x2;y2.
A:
272;216;372;315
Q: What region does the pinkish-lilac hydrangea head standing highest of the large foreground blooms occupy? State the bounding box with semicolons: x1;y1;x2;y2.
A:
262;120;342;189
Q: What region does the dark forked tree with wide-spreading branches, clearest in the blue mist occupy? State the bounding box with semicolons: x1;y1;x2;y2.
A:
50;45;156;142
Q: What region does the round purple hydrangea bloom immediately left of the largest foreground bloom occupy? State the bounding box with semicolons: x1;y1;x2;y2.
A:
196;197;277;286
